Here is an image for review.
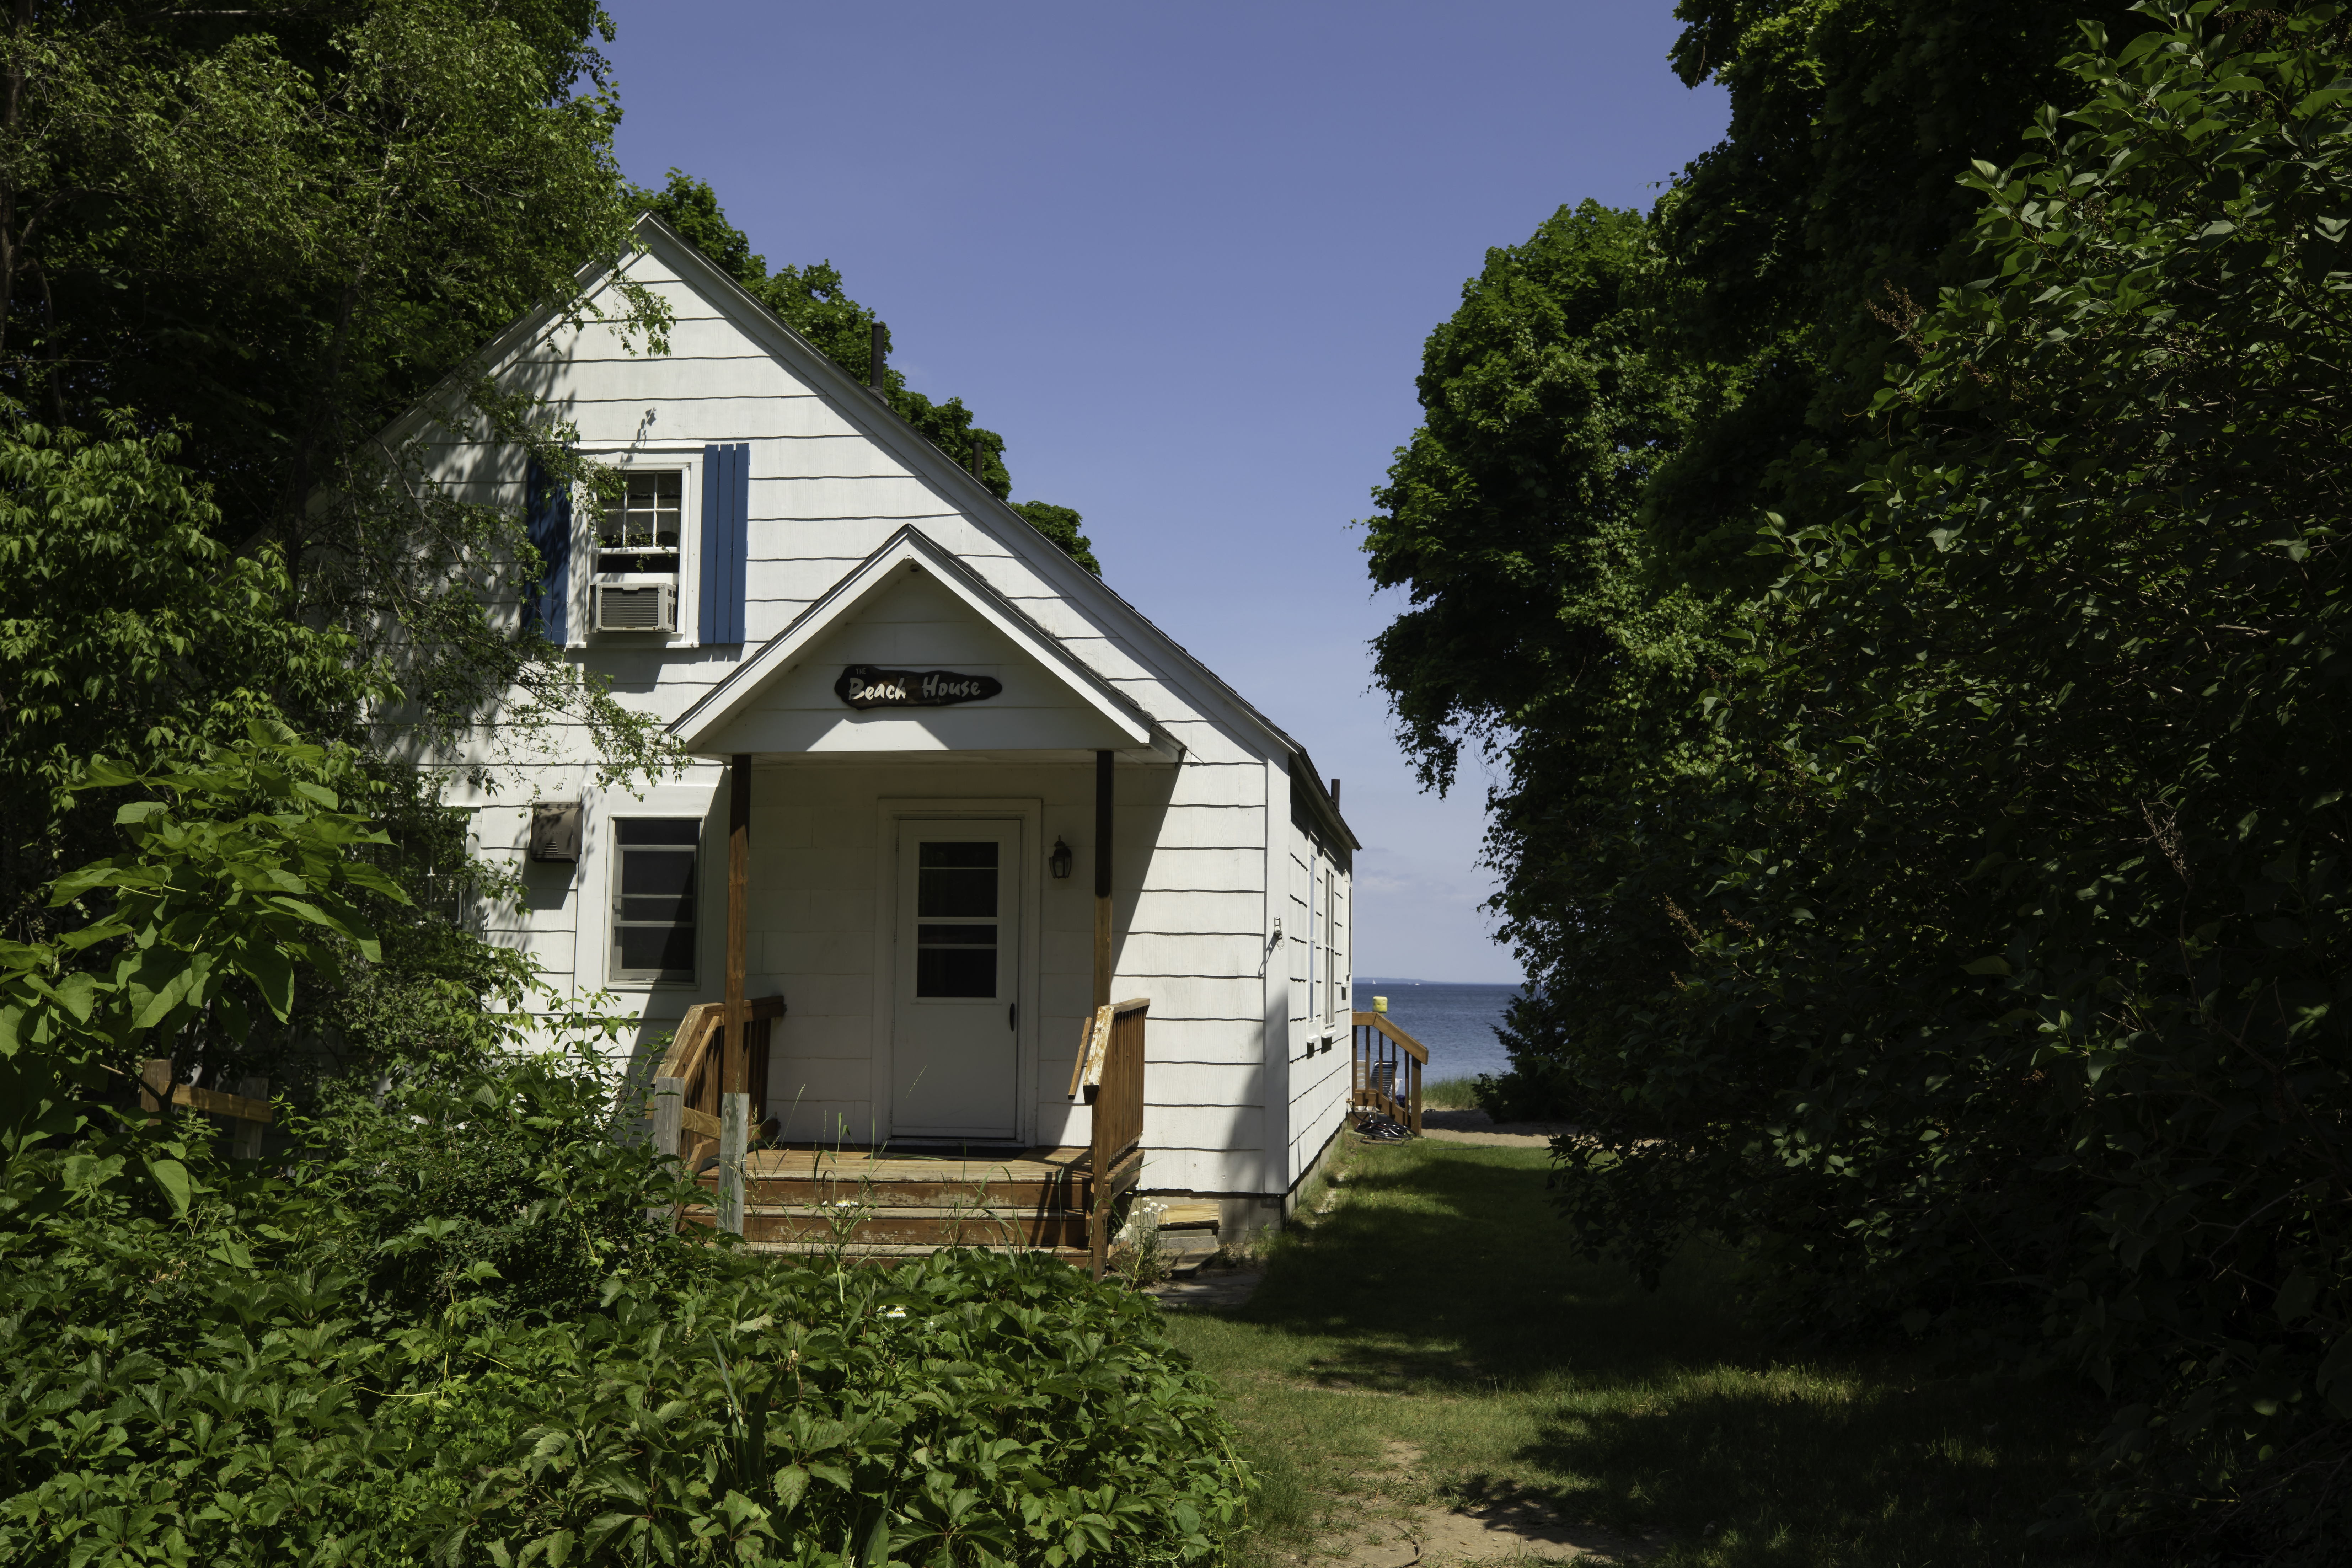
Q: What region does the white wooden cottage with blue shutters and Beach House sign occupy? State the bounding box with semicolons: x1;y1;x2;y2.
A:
397;216;1392;1225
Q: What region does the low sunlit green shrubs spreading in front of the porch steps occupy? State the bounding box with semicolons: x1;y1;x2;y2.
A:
0;1060;1249;1568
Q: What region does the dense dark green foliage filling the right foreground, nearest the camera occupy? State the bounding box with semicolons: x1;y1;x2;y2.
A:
1376;0;2352;1561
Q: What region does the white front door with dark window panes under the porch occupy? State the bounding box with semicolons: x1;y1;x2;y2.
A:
891;820;1023;1140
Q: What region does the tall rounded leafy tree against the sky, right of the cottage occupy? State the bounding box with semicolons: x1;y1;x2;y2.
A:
1366;0;2154;1114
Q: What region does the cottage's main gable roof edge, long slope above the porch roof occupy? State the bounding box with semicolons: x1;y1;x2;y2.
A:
384;212;1362;849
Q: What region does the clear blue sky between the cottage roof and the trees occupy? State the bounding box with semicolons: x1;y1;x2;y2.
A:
607;0;1729;980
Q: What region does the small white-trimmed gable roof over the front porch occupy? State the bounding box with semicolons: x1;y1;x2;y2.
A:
668;524;1183;762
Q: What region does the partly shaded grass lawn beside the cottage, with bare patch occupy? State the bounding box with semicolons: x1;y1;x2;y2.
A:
1169;1140;2103;1568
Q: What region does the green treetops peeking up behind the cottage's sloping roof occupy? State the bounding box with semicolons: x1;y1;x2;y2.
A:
637;169;1103;576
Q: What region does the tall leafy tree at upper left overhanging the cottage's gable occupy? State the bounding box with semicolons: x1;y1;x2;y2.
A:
0;0;682;846
